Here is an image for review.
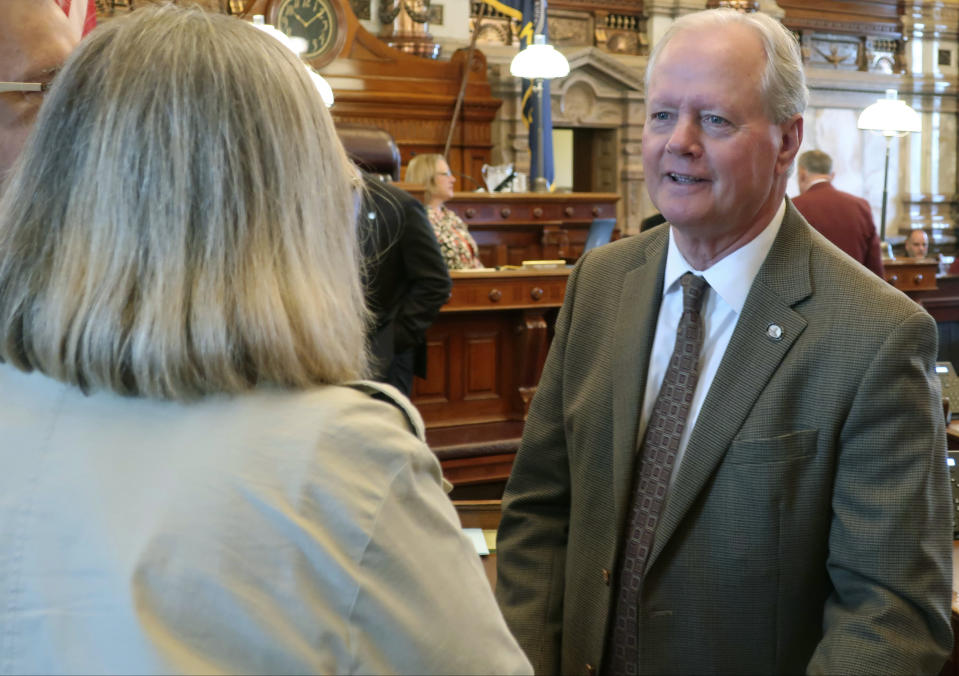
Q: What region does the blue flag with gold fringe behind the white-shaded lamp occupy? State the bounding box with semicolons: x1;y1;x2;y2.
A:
483;0;554;186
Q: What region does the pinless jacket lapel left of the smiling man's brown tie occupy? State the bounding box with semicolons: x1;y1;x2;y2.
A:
612;230;669;516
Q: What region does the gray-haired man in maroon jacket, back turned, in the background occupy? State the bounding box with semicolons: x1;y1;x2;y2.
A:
793;150;883;277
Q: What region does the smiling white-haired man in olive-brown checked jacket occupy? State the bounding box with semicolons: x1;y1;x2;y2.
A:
496;10;952;674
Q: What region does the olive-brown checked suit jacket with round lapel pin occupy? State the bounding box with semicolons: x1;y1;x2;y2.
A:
496;205;952;674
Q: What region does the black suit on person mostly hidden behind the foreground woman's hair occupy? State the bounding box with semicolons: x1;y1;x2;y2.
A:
359;174;452;384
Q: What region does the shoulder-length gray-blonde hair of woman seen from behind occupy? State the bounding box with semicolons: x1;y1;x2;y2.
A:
0;5;366;399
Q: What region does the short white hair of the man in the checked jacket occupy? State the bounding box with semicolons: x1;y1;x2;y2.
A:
646;7;809;124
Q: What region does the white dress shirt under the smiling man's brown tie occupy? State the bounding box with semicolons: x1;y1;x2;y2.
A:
639;200;786;482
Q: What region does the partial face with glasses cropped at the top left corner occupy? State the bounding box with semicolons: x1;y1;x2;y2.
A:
0;0;79;183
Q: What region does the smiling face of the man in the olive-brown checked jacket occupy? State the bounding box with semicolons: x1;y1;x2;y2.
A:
643;25;802;252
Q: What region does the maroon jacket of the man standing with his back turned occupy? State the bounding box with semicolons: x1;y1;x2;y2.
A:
793;181;883;277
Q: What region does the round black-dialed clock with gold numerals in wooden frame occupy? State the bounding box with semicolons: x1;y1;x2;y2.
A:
266;0;346;68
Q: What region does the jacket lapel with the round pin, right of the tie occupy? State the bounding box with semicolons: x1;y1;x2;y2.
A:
647;203;812;566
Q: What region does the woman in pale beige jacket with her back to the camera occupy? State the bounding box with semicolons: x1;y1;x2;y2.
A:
0;5;531;674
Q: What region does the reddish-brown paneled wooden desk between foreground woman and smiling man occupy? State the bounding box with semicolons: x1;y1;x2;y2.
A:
412;267;569;497
